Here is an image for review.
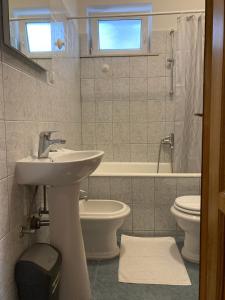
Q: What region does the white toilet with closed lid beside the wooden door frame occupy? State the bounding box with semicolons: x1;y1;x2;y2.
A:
170;195;201;263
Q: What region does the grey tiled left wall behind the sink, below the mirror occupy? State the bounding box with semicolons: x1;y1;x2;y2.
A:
0;21;81;300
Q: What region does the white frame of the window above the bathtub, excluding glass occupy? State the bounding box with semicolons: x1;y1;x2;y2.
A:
90;14;149;56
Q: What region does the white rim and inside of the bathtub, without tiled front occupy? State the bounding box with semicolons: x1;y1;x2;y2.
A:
91;162;201;177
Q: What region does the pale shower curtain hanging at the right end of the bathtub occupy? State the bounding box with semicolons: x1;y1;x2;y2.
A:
174;14;205;173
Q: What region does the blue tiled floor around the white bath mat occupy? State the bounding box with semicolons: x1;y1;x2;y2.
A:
88;239;199;300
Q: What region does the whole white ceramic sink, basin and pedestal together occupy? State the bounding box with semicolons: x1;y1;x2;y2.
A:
16;149;104;300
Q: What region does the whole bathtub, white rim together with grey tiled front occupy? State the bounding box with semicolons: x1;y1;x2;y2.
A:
85;162;201;236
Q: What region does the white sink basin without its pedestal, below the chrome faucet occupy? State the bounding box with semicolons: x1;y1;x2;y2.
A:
16;149;104;186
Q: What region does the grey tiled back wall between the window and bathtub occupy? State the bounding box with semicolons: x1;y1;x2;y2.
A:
81;31;175;161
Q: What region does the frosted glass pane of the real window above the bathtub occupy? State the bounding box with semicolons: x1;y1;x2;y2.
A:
99;19;142;50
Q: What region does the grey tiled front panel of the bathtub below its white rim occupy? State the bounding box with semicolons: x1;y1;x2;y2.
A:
82;175;200;236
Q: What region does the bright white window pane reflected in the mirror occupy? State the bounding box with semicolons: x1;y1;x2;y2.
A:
27;23;52;52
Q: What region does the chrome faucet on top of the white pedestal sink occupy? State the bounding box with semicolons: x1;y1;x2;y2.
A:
38;131;66;158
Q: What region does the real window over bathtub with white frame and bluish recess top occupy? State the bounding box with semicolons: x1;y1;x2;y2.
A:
88;4;151;55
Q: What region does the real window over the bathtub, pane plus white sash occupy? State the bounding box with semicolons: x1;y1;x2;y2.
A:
91;17;149;55
